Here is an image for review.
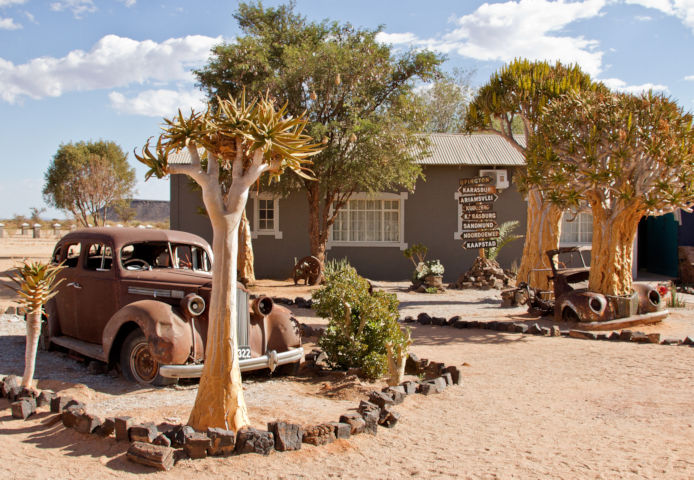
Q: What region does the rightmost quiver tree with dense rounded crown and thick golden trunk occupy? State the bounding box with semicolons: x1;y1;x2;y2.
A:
528;88;694;295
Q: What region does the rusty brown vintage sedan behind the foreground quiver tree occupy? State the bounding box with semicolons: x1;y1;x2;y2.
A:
41;227;303;385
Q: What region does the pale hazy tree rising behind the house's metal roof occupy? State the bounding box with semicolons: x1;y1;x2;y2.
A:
419;69;474;133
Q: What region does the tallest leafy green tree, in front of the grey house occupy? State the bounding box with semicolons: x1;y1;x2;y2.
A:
196;3;442;280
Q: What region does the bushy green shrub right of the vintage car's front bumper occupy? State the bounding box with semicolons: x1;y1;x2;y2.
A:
313;262;409;379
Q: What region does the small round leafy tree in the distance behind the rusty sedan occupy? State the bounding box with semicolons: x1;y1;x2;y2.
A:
43;140;135;227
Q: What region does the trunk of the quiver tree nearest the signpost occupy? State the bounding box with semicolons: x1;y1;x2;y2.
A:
516;188;563;290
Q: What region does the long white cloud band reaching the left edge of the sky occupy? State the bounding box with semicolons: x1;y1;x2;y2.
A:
0;35;222;103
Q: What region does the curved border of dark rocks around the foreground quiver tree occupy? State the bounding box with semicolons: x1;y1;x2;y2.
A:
0;355;468;471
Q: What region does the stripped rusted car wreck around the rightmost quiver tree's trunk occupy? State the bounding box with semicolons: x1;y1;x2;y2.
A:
547;247;668;330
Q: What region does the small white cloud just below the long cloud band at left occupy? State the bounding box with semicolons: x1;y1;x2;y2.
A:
108;89;207;117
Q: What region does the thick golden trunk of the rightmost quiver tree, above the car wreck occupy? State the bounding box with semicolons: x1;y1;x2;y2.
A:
588;206;642;295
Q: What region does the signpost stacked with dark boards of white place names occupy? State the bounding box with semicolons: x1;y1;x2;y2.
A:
458;176;499;251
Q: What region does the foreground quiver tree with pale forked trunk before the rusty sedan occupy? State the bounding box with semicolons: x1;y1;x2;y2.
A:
136;95;320;430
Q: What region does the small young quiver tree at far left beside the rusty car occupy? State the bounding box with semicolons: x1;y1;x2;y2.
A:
10;260;64;388
